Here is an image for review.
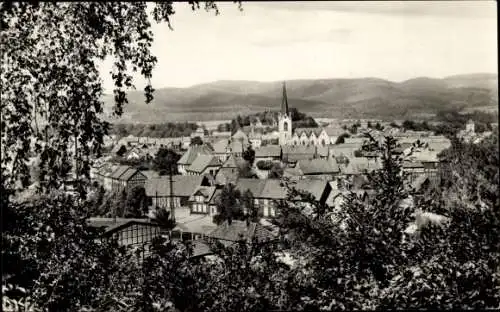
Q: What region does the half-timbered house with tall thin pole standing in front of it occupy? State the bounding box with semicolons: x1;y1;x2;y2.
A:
145;175;206;210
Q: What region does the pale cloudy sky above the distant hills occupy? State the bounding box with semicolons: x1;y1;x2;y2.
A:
97;0;498;91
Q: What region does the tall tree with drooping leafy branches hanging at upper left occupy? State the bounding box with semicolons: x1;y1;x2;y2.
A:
0;2;225;193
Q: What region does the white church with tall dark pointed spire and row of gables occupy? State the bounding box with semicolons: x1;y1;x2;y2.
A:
278;82;345;146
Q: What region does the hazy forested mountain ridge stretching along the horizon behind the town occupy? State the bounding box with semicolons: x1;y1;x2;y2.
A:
104;74;498;123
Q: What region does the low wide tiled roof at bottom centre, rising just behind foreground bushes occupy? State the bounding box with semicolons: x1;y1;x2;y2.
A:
208;220;276;242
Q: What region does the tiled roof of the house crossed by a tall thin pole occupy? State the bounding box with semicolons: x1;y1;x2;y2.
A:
145;175;203;197
